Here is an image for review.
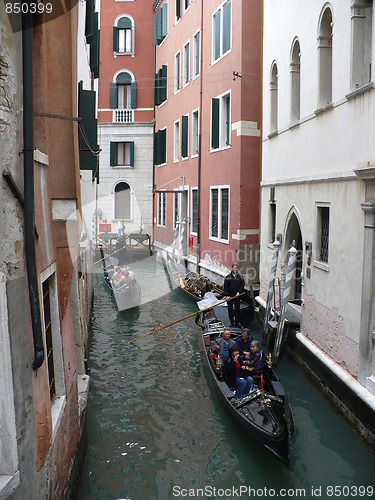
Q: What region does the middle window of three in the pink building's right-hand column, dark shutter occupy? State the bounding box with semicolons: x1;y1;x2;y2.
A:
211;93;231;149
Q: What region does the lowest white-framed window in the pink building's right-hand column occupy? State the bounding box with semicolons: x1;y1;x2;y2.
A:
210;187;229;241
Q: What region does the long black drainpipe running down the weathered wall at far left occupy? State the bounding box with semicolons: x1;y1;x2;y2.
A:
22;12;44;370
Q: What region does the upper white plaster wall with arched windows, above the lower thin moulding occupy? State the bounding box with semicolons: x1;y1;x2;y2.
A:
263;0;375;181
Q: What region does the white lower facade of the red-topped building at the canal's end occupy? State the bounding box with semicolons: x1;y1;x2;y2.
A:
98;123;154;234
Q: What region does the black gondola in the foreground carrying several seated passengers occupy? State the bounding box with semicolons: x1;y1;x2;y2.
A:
197;307;294;465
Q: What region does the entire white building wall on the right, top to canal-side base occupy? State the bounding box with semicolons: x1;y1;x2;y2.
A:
261;0;375;376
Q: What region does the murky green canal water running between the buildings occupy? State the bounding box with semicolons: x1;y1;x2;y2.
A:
78;259;375;500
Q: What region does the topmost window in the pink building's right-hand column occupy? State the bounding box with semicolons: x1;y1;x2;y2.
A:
212;0;232;61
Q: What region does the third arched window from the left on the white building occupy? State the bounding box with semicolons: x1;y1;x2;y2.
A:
318;7;333;108
